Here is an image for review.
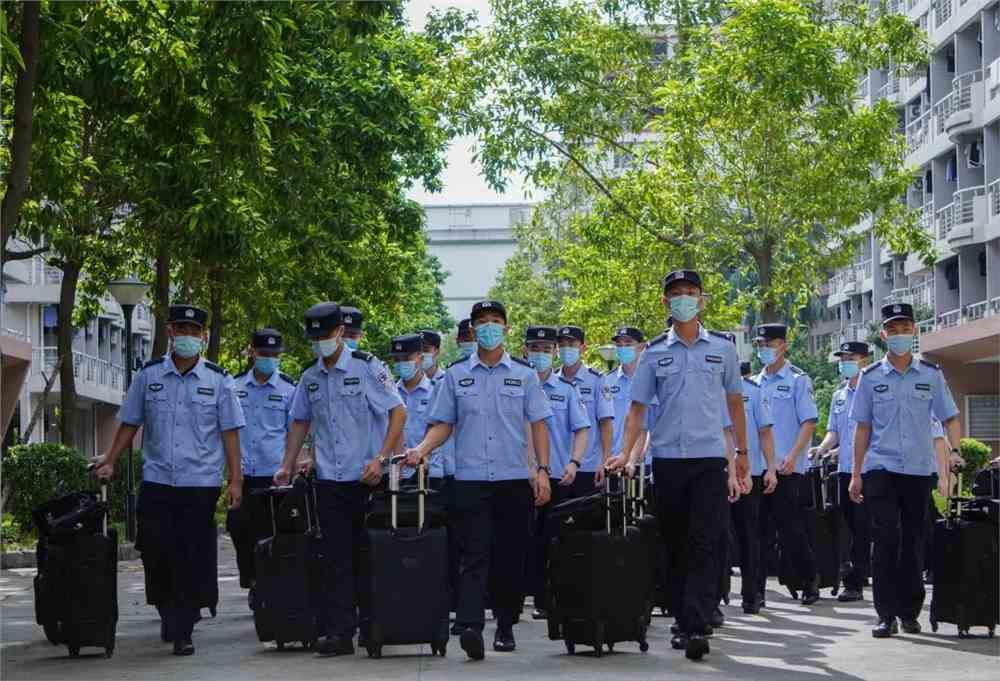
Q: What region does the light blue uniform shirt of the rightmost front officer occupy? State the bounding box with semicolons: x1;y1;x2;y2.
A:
850;357;958;476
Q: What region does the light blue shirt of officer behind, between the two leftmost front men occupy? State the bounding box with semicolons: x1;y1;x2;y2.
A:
235;369;295;478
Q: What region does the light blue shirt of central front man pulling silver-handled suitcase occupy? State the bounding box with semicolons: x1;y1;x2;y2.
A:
429;352;552;482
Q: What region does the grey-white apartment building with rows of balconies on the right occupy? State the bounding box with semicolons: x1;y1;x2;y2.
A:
813;0;1000;453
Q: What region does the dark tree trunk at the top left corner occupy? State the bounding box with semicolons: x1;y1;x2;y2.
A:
0;0;42;255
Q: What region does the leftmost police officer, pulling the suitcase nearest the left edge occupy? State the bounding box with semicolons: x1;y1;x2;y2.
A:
96;305;244;655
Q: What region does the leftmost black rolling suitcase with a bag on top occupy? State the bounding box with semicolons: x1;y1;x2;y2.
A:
33;476;118;657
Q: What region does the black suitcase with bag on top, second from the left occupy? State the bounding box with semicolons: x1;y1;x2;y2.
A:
251;476;322;650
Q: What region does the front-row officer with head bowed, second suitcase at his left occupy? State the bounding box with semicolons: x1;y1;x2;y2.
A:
274;302;406;657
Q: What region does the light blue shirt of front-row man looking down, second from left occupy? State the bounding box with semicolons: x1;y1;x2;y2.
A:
292;347;402;482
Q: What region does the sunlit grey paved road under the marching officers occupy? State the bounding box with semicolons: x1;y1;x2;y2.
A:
0;537;1000;681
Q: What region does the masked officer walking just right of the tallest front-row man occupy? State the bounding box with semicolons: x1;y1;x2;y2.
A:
756;324;819;605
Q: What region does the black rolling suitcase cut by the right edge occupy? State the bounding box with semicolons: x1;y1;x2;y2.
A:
931;478;1000;638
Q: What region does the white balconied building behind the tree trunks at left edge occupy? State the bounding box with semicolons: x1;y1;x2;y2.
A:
0;257;154;456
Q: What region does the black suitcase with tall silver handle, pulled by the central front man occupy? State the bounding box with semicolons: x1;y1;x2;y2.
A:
363;456;450;658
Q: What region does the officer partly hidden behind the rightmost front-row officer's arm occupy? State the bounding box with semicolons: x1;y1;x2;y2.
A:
815;341;871;603
